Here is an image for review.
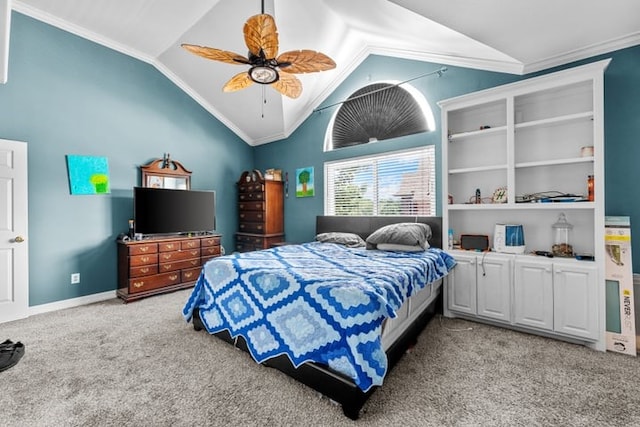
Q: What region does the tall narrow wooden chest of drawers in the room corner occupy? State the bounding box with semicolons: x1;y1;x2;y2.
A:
236;170;284;252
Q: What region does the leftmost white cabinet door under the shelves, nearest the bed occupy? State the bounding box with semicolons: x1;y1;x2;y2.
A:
447;254;476;314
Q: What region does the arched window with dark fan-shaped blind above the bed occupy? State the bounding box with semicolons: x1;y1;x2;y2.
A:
325;83;432;151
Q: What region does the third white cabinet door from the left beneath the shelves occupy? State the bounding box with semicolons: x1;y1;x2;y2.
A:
513;258;553;331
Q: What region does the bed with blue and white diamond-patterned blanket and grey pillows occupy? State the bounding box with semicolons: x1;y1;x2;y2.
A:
183;216;455;420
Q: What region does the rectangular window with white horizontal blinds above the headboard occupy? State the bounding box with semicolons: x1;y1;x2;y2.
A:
324;145;436;216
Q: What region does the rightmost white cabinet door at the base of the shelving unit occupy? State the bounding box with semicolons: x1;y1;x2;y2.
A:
553;262;598;340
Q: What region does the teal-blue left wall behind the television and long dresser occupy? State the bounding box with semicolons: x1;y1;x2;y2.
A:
0;12;253;305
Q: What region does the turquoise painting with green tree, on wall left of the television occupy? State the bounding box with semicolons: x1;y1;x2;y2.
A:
67;154;111;194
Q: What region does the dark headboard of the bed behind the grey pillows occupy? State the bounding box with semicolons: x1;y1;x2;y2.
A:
316;215;442;248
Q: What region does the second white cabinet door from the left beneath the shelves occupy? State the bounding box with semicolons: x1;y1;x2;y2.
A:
476;254;512;322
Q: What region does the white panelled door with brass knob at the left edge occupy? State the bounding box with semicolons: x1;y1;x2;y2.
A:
0;139;29;323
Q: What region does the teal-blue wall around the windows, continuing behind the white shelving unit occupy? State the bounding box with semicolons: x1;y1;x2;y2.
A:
255;46;640;272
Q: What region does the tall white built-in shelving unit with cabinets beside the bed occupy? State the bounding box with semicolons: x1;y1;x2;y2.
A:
439;60;610;350
